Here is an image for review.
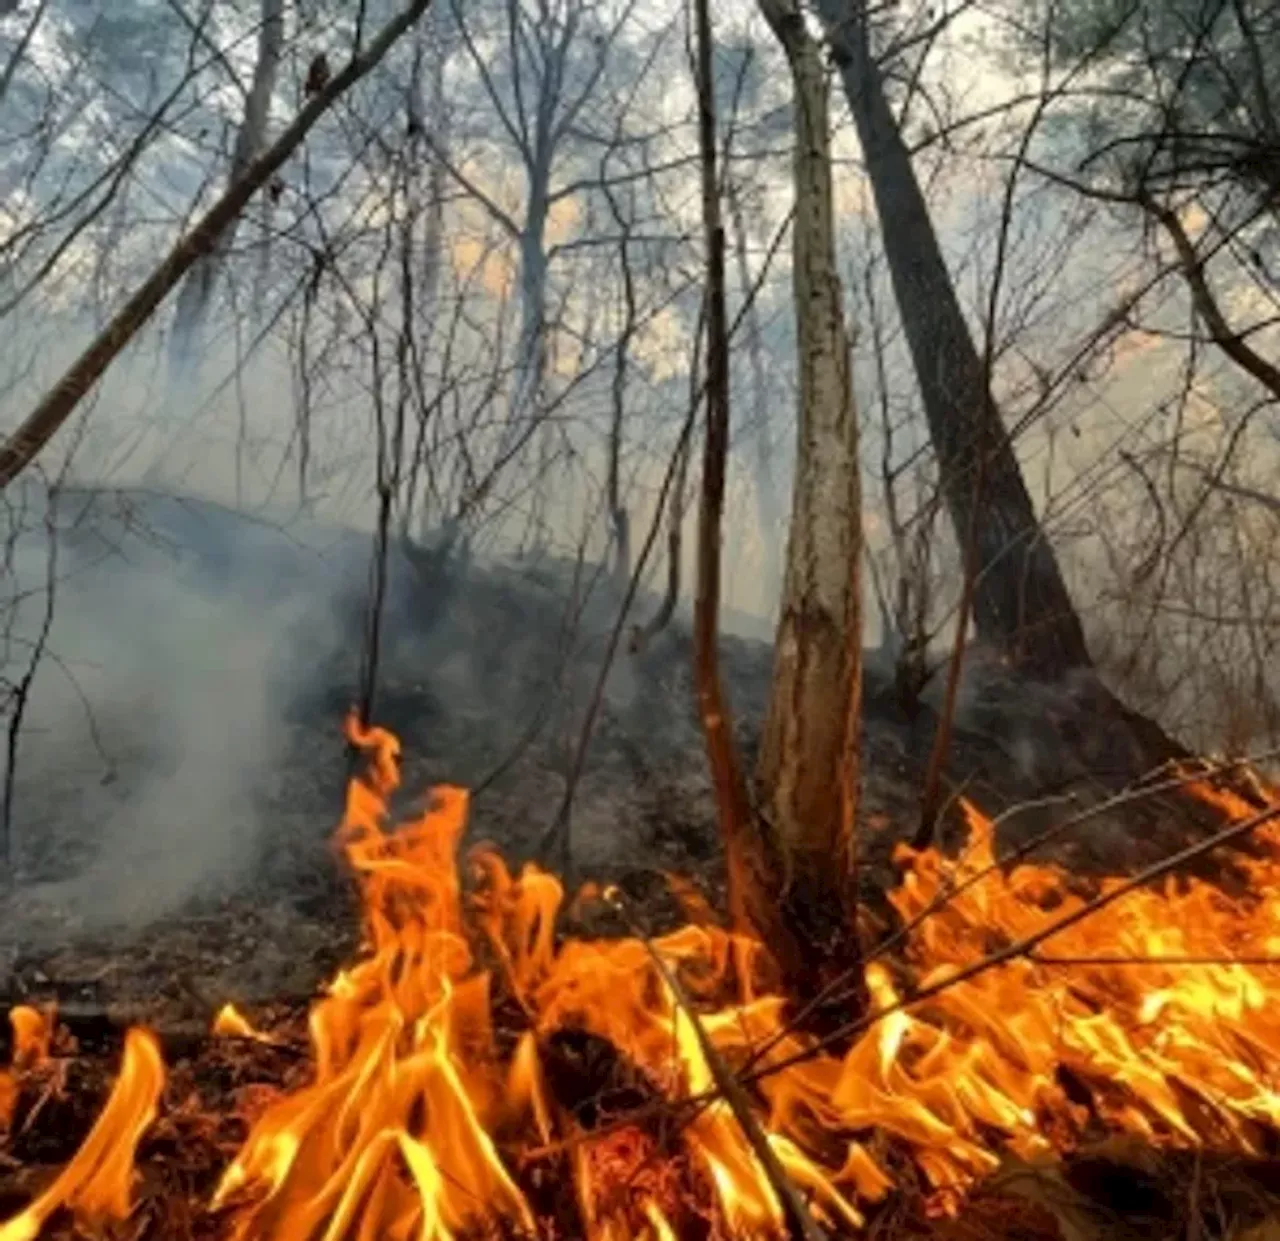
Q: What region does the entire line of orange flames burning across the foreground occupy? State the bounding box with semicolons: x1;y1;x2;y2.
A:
0;725;1280;1241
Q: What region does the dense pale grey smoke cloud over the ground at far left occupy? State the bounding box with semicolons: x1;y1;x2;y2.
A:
6;494;363;929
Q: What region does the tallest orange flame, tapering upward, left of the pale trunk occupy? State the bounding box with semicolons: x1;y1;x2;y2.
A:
214;722;534;1241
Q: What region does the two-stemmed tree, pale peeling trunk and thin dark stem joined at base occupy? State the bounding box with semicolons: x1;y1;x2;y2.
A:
694;0;861;999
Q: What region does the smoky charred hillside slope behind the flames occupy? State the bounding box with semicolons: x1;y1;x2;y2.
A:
0;488;1239;1009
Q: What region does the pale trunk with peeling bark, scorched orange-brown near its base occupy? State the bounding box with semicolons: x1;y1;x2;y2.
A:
759;0;861;995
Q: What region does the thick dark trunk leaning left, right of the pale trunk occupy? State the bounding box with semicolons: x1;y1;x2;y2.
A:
815;0;1091;676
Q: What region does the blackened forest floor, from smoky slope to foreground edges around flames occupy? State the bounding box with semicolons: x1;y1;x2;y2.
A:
0;493;1280;1241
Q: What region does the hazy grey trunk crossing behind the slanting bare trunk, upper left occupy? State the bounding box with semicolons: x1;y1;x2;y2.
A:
172;0;284;367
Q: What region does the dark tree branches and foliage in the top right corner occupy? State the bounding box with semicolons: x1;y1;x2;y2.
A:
1023;0;1280;397
